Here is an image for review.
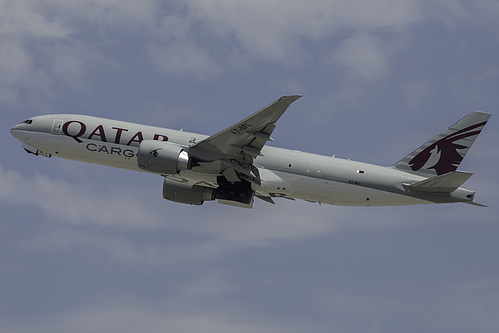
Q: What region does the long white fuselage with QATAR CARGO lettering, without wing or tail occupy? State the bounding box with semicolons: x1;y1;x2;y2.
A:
11;114;473;206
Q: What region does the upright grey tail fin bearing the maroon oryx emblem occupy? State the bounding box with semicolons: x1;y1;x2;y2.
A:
394;111;491;177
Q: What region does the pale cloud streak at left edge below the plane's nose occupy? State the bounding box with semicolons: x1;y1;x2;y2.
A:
0;165;161;229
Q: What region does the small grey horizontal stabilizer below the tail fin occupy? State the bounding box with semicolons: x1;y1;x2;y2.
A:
409;171;473;193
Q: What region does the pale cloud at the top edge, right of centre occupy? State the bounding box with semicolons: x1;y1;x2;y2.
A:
184;0;420;65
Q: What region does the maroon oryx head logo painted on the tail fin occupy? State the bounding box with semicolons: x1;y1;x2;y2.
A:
409;122;485;175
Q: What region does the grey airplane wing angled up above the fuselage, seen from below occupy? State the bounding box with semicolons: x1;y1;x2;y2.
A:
190;95;302;183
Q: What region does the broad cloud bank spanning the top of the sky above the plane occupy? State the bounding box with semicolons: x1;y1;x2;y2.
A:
0;0;498;104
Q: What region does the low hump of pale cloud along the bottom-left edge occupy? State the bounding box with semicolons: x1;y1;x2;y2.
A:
2;297;305;333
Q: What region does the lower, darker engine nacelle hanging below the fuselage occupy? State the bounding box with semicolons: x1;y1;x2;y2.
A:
163;178;216;205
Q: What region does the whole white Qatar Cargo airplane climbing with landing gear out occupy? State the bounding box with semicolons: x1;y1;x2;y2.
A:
11;95;491;208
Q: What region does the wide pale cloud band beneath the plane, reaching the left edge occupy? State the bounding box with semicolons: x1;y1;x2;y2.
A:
0;165;344;266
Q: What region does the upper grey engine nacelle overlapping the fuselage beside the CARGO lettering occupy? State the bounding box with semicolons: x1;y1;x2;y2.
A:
137;140;190;175
